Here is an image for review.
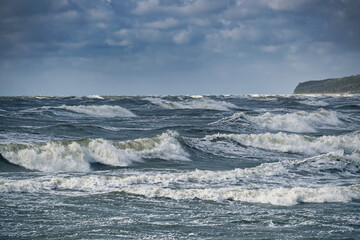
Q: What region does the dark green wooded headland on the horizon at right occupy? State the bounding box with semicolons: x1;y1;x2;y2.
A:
294;74;360;94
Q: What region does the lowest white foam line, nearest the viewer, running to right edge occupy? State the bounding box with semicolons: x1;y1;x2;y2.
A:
122;185;360;206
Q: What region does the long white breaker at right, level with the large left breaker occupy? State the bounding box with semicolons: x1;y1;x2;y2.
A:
202;131;360;155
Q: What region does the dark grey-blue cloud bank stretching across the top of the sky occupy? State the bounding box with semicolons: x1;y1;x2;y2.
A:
0;0;360;56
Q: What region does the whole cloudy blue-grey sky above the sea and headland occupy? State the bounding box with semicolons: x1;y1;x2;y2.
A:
0;0;360;96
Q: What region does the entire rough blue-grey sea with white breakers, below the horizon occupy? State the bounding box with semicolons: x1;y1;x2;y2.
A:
0;95;360;239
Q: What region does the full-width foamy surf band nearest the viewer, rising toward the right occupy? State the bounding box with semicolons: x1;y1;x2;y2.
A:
0;153;360;206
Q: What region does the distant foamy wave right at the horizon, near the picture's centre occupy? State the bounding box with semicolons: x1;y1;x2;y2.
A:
145;97;237;111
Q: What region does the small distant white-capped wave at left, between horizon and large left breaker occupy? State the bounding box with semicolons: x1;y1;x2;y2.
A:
57;105;136;117
